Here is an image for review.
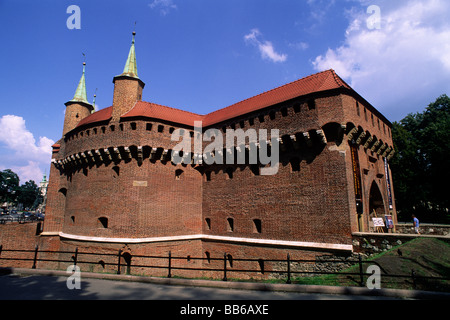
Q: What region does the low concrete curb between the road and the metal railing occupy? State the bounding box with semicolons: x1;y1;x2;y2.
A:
0;268;450;300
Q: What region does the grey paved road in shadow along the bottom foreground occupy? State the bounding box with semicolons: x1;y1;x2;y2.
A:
0;274;396;300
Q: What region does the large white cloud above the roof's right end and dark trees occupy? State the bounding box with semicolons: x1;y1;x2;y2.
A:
313;0;450;116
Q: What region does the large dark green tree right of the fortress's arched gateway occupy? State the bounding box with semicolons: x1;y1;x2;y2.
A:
391;95;450;222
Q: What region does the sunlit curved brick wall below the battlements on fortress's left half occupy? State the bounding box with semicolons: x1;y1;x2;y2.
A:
62;161;201;238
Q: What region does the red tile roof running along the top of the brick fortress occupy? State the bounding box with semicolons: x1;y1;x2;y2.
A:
77;70;352;127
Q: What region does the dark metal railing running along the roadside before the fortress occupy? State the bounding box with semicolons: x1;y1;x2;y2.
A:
0;245;450;288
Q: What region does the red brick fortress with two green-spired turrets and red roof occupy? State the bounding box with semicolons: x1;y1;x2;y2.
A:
22;34;396;278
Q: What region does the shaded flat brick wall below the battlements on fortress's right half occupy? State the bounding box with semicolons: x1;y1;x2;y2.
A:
203;142;351;243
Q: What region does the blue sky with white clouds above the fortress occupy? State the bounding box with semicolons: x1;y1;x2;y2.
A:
0;0;450;183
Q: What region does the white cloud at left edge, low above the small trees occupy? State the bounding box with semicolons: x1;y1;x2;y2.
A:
0;115;54;183
